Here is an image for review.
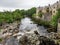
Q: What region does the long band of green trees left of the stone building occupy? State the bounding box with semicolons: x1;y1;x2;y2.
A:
0;7;36;25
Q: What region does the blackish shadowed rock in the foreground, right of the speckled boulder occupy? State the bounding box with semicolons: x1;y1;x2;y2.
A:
40;36;56;45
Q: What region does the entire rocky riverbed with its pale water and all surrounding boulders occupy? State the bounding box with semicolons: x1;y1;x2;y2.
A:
0;18;60;45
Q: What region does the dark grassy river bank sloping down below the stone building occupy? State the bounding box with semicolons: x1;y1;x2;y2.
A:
32;17;57;33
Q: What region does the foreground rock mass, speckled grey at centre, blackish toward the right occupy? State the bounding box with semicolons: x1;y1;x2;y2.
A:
19;33;56;45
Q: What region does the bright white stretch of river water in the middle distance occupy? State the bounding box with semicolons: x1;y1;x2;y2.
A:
19;17;37;30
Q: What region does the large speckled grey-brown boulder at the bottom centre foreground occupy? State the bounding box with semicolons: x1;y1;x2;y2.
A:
19;34;40;45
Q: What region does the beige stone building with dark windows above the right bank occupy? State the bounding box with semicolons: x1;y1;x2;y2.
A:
36;0;60;21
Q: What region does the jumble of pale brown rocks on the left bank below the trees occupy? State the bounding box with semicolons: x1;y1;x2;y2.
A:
1;22;19;38
